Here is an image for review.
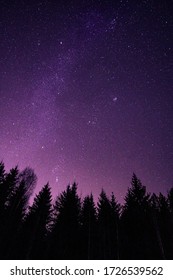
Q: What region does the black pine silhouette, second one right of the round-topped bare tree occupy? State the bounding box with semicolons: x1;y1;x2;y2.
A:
51;183;81;259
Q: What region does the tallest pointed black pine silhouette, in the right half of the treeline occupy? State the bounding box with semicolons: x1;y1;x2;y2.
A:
121;174;151;259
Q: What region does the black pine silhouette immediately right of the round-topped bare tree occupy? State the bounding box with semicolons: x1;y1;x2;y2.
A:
22;184;52;259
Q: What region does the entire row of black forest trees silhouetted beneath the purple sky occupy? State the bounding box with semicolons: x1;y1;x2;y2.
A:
0;162;173;259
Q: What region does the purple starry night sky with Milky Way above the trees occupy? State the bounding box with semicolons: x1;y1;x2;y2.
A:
0;0;173;201
